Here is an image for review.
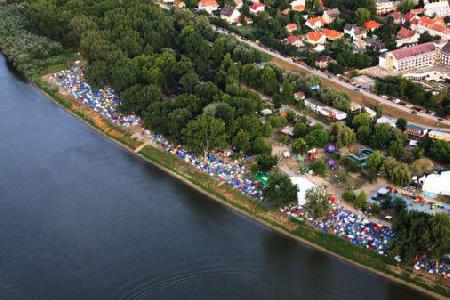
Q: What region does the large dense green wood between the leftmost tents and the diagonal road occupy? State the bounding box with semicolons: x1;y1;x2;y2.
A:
21;0;282;154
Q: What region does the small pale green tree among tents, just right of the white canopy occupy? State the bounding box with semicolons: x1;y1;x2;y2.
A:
304;187;331;219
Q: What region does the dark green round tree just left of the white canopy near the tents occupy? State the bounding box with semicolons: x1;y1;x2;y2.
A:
263;172;297;208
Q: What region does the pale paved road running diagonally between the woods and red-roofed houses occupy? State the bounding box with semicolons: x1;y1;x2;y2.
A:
211;25;450;132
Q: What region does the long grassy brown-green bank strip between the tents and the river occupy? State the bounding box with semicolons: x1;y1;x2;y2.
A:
33;73;449;299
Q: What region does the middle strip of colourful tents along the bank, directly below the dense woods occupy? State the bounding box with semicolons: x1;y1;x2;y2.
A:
151;134;262;200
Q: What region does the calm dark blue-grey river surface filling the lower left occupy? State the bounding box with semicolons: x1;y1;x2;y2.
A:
0;56;430;300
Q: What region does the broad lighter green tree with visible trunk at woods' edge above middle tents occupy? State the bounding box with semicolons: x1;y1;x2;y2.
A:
182;116;225;159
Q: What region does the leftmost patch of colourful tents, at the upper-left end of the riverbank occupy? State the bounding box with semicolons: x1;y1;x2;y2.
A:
50;64;140;127
